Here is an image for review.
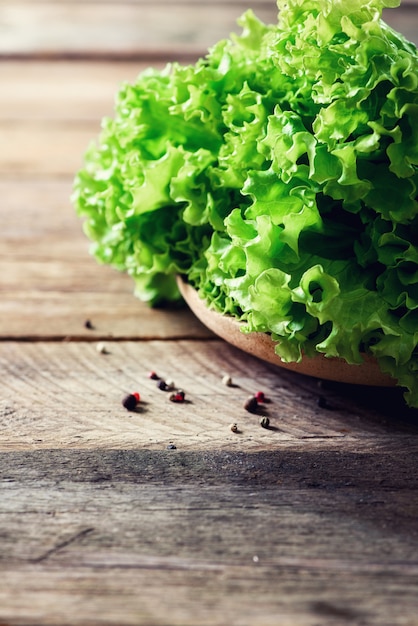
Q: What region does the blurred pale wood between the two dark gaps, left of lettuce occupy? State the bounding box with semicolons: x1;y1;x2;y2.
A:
0;63;207;340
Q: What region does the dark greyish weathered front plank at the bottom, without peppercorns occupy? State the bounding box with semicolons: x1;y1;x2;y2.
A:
0;450;418;626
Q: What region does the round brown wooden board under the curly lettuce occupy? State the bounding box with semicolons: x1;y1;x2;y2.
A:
177;277;396;387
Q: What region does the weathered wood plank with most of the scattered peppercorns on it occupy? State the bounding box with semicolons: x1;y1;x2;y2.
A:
0;340;418;455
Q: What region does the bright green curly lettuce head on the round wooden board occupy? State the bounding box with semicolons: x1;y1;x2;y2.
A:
73;0;418;407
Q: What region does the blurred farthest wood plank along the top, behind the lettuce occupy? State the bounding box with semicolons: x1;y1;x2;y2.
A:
0;1;277;57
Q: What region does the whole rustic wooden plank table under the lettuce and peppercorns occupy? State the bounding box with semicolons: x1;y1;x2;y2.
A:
0;0;418;626
